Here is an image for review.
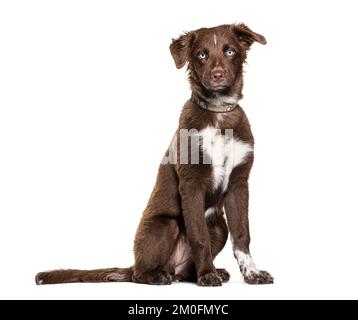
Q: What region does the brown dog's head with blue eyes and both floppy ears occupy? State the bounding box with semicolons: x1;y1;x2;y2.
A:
170;24;266;97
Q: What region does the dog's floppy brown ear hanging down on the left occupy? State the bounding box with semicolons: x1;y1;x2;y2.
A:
169;32;195;69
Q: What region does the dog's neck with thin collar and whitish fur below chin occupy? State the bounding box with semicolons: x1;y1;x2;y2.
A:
191;93;240;113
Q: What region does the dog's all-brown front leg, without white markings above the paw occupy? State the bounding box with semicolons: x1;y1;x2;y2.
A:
180;183;222;286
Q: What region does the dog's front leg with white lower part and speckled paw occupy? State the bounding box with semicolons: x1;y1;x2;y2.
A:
224;178;273;284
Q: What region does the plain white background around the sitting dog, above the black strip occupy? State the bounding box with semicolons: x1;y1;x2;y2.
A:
0;0;358;299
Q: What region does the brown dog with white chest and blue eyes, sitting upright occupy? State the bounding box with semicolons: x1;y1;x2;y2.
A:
36;23;273;286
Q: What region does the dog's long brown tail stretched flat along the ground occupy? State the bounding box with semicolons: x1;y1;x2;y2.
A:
35;267;133;285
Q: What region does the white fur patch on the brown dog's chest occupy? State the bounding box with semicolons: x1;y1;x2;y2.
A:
199;127;253;192
